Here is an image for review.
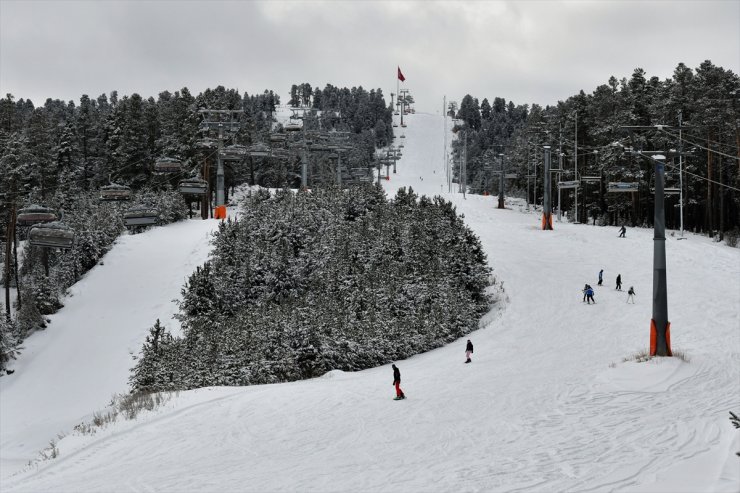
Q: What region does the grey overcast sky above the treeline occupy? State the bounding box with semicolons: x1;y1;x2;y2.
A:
0;0;740;112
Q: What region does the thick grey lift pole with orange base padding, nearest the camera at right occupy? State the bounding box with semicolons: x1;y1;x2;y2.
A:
650;154;672;356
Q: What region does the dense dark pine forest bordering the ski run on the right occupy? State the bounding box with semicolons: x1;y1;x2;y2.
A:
450;61;740;239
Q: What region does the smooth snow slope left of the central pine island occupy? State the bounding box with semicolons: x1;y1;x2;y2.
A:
0;220;223;476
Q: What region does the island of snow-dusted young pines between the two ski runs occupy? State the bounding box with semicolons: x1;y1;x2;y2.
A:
130;186;491;391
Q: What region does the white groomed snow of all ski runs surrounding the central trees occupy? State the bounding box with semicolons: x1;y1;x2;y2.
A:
0;109;740;492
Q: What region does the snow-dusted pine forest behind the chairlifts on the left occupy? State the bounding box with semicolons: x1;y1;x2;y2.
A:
0;86;391;370
